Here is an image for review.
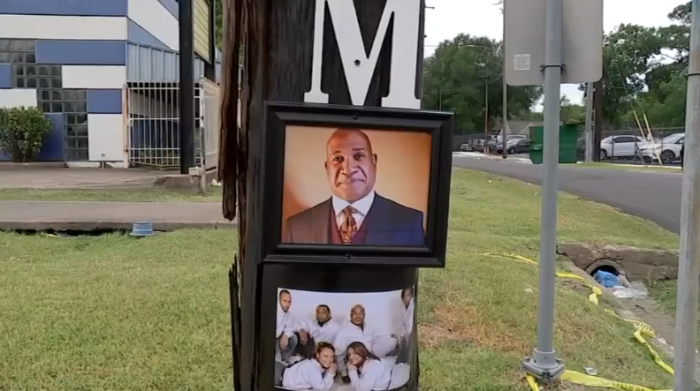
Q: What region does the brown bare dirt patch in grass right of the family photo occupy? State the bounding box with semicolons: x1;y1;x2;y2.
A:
419;304;532;354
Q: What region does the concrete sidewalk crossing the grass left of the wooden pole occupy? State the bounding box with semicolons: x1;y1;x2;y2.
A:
0;201;236;231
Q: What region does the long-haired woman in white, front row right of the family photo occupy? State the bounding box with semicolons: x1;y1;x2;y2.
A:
347;342;392;391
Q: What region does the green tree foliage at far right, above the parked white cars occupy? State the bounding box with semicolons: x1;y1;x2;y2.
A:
581;2;692;128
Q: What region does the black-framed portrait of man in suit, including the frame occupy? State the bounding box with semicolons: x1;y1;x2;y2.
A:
262;102;453;267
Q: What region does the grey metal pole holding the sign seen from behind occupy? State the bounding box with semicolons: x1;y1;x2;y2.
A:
523;0;568;382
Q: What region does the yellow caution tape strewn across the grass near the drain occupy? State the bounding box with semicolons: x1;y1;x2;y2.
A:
482;252;673;391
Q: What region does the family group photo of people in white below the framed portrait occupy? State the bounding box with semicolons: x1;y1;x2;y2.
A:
274;286;416;391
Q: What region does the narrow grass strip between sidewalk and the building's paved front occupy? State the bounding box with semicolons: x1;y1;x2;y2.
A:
0;187;221;202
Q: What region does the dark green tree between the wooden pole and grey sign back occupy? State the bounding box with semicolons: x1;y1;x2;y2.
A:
423;34;542;133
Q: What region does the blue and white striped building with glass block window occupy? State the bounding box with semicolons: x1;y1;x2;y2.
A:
0;0;219;166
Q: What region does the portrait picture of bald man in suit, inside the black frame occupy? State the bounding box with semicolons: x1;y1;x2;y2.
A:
282;126;432;247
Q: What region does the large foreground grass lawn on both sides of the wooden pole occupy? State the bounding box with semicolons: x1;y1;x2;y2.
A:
0;169;677;391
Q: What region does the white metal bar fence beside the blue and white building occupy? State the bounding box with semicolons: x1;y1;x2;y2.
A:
126;79;219;169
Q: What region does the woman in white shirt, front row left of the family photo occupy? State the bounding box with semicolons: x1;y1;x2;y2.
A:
282;342;337;391
